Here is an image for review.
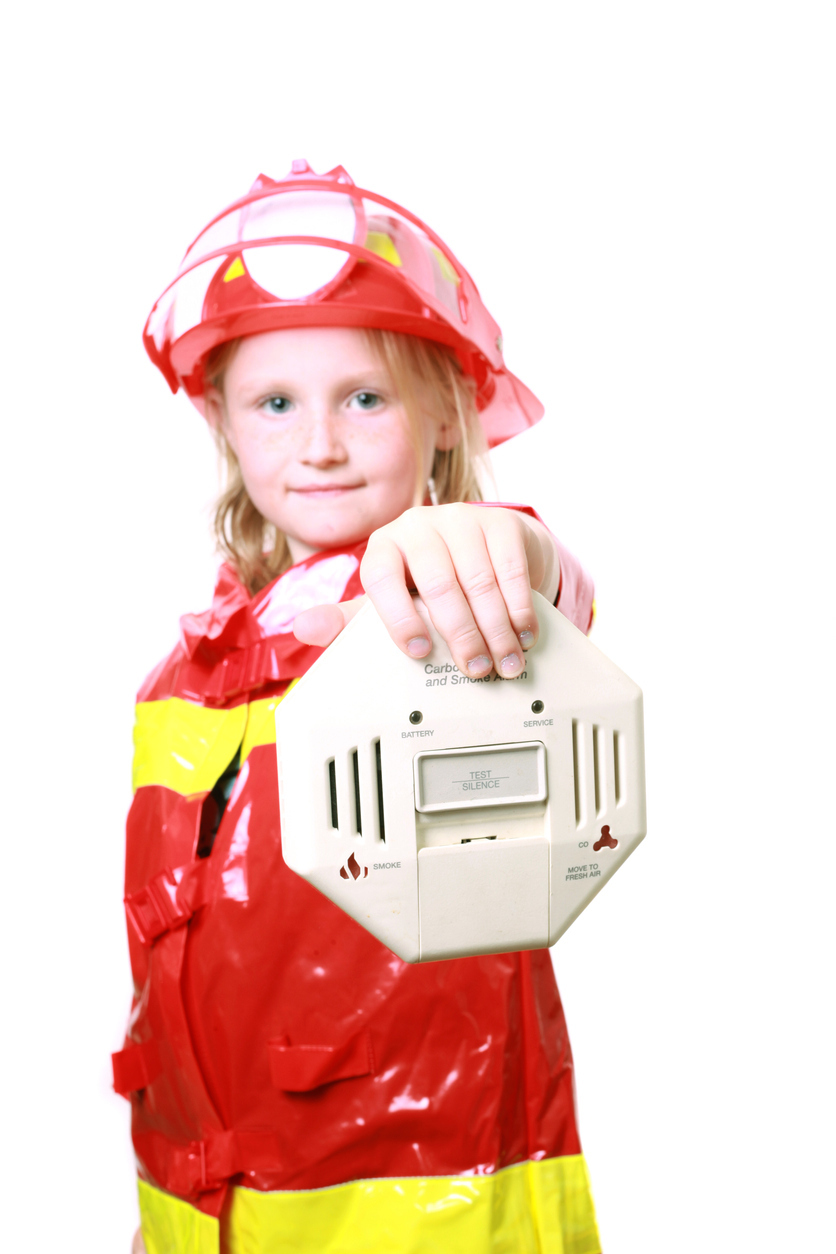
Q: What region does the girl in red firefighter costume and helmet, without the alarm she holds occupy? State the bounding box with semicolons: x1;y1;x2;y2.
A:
114;162;600;1254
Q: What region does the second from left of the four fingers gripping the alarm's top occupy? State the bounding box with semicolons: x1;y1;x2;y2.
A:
391;527;494;678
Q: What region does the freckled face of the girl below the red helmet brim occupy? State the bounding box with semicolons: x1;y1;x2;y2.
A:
207;327;436;562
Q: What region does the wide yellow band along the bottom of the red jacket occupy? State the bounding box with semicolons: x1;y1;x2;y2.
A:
139;1154;600;1254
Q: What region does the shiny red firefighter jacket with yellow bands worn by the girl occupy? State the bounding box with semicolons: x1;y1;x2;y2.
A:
114;514;598;1254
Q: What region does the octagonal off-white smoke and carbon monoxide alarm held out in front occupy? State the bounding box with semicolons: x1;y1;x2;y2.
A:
276;593;645;962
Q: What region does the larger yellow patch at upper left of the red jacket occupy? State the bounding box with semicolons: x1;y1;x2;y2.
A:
133;697;247;796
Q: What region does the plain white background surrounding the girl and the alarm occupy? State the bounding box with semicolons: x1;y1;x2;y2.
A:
0;0;836;1254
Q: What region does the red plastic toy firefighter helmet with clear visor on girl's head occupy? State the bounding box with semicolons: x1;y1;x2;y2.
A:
143;161;543;446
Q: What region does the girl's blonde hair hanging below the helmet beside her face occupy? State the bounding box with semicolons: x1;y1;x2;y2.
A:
206;330;488;596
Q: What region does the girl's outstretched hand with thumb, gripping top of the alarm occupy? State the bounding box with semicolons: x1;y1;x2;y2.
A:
293;504;560;678
